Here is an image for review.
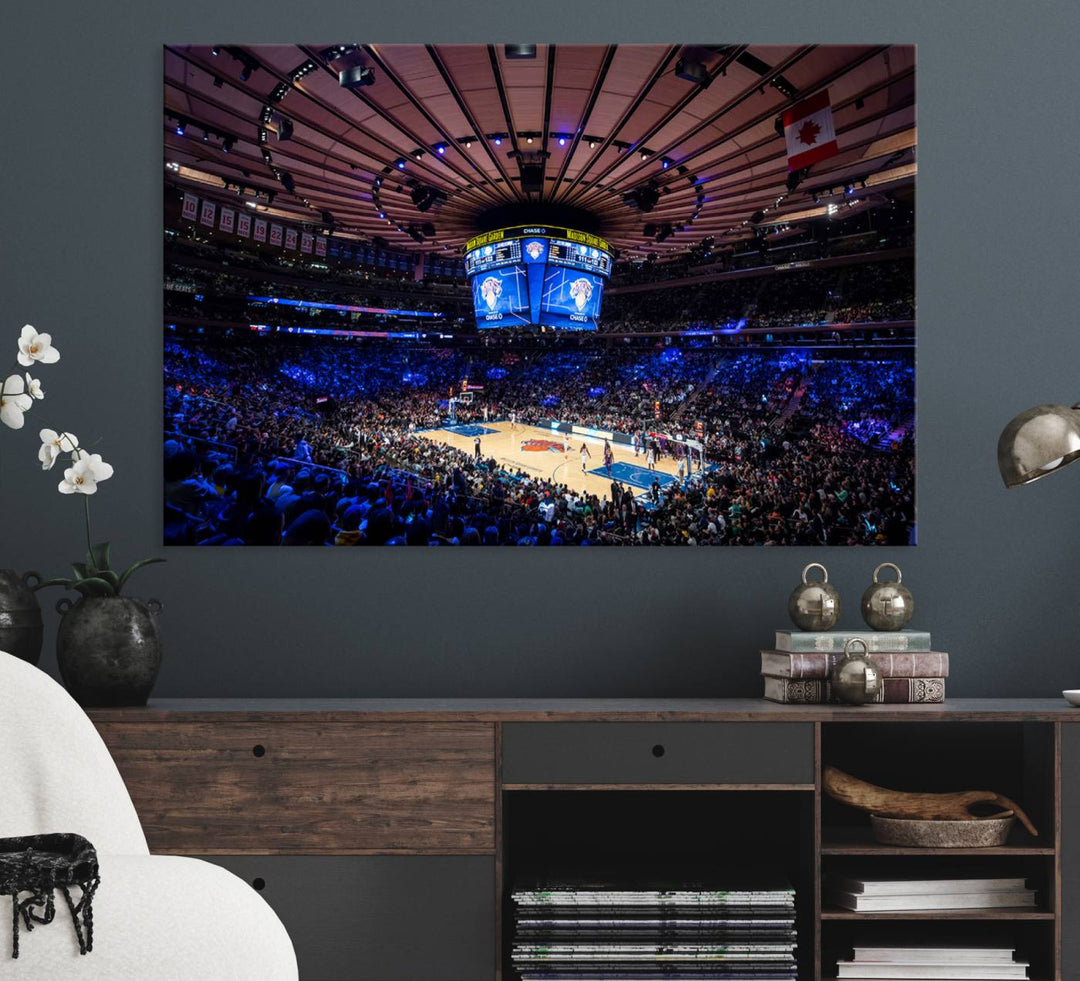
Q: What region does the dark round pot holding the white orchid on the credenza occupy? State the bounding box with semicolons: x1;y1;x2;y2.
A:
56;596;161;707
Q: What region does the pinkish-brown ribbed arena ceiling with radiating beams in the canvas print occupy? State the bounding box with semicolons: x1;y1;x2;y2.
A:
163;44;916;257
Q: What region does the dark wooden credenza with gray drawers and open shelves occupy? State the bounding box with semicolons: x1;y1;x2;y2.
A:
91;699;1080;981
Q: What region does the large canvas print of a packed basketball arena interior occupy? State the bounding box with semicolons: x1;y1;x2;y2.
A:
163;43;917;547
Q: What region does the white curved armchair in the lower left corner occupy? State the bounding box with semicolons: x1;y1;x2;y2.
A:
0;651;297;981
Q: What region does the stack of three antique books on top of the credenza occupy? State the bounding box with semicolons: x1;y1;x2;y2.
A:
761;630;948;704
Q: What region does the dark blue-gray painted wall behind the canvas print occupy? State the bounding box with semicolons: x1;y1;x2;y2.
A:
0;0;1080;696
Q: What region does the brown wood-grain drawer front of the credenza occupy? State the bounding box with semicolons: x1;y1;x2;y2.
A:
98;721;495;855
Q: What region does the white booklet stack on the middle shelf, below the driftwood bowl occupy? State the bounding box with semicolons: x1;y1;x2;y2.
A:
825;875;1035;913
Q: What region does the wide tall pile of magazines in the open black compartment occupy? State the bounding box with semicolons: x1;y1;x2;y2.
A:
511;879;797;981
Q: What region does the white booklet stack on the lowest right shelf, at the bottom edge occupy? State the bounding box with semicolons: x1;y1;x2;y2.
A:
837;946;1029;981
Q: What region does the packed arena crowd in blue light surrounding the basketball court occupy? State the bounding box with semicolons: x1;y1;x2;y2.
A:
164;334;914;546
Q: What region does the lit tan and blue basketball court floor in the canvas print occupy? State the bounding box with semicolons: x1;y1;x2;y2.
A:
421;421;678;498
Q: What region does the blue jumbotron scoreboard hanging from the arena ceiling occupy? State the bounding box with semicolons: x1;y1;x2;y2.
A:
465;225;612;331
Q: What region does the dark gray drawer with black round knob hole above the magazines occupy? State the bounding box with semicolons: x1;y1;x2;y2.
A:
502;722;814;787
